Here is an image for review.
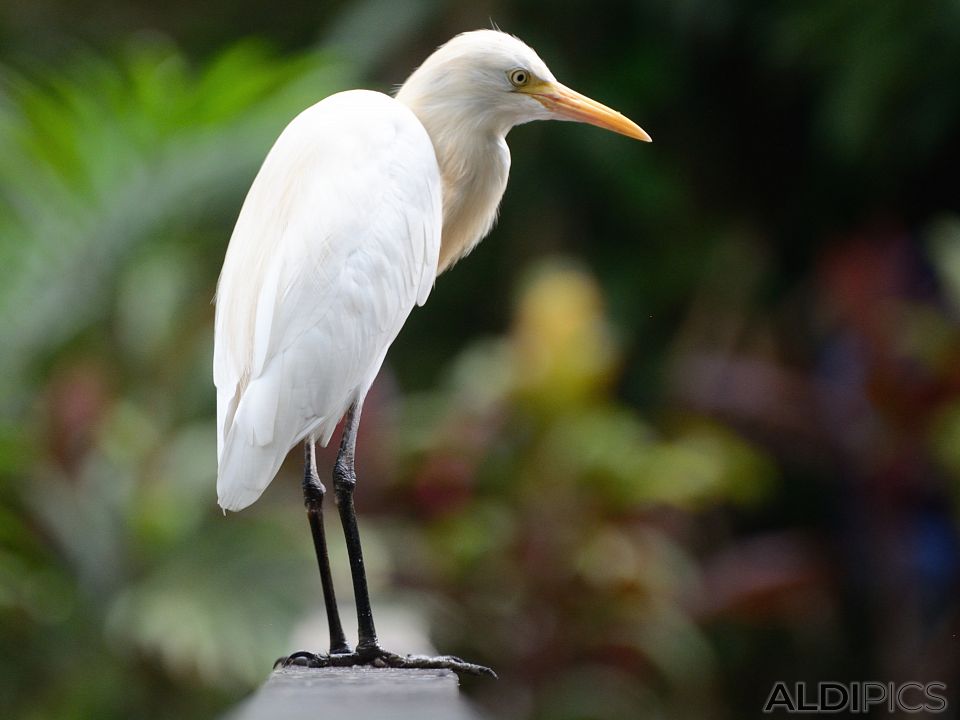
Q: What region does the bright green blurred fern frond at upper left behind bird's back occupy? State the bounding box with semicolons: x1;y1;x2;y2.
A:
0;42;352;408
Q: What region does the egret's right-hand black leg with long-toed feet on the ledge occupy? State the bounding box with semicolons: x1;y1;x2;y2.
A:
274;403;497;677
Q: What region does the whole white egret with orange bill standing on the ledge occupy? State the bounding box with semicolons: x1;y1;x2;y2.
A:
213;30;650;672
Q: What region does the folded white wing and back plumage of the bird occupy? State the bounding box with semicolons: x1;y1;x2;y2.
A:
213;90;442;510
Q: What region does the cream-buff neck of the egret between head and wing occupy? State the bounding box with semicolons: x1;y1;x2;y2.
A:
398;95;510;273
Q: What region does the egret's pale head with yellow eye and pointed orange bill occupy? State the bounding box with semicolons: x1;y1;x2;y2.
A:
397;30;651;142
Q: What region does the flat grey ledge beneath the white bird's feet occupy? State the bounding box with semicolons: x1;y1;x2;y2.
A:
224;667;481;720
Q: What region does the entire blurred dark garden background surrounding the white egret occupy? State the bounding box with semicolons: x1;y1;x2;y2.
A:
0;0;960;720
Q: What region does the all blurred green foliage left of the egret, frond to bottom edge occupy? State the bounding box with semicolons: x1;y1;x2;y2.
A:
0;42;346;718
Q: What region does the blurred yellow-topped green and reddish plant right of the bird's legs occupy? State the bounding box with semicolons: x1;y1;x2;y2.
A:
397;262;776;718
